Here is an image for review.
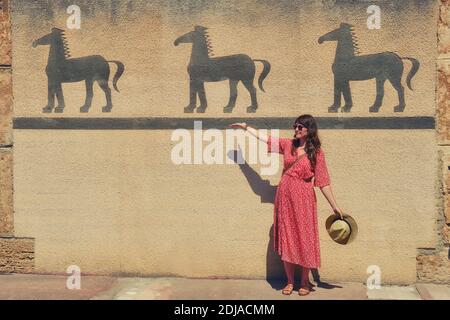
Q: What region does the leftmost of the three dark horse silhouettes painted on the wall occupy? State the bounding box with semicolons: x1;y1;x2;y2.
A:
33;28;125;113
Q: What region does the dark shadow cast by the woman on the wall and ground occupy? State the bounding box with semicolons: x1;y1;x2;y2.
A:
228;149;342;290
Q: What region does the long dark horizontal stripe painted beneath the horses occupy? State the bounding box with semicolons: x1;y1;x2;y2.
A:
14;117;435;130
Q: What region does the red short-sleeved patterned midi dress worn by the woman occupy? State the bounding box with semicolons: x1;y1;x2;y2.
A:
268;137;330;268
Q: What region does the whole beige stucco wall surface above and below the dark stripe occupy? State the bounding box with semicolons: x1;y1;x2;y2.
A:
9;1;440;283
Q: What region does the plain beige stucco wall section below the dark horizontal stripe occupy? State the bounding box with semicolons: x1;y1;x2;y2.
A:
14;130;437;283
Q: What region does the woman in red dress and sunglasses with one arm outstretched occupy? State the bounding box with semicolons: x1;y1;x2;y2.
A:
230;115;342;296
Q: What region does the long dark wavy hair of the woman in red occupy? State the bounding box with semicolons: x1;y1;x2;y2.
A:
292;114;321;167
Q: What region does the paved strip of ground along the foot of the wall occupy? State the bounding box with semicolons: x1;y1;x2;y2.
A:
0;275;450;300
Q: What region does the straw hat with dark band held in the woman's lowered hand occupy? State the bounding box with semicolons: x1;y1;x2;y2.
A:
325;214;358;244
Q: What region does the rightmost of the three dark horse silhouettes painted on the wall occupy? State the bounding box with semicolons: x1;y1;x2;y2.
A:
319;23;420;112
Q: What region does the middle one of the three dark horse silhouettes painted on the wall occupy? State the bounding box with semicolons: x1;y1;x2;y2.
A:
174;26;270;113
